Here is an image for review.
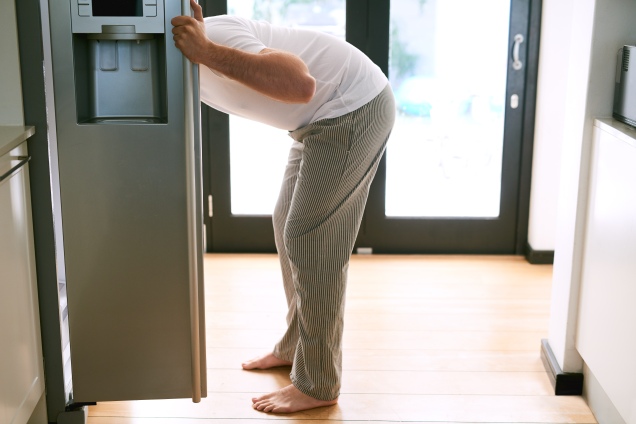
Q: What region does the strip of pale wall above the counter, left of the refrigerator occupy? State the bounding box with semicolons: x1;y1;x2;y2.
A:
0;0;24;125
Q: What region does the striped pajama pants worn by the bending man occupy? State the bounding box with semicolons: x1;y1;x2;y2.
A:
273;85;395;400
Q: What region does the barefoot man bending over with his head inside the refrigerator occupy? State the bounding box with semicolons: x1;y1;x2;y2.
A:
172;0;395;413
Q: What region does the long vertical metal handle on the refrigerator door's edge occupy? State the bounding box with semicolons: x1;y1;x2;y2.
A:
182;0;201;403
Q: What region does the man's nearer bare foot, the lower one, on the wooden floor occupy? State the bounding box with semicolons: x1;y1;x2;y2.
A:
252;384;338;414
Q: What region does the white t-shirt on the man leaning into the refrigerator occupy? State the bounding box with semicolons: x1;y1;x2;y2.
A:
200;15;388;131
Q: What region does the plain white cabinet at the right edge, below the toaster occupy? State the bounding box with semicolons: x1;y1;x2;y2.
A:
577;119;636;424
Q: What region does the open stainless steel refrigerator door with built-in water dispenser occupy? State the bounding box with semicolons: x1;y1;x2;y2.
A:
49;0;206;403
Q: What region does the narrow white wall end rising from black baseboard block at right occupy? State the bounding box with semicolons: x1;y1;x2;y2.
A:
548;0;596;372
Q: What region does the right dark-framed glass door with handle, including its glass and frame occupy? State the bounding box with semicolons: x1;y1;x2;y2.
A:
356;0;536;253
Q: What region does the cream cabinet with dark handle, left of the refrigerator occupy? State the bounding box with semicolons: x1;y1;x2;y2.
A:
0;127;44;424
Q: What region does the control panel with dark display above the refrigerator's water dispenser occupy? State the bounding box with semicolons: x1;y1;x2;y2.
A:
71;0;165;34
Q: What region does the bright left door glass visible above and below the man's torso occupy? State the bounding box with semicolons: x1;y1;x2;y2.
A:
227;0;346;215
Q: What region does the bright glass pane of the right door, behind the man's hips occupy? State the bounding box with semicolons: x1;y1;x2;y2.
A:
385;0;510;218
